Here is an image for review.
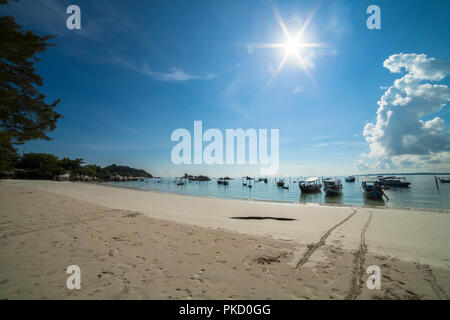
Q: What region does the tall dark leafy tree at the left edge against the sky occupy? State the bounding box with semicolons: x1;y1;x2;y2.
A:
0;0;61;170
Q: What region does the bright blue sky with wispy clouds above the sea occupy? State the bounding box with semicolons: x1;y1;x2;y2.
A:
0;0;450;176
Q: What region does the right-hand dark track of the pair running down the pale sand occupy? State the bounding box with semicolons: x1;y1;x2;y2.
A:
345;212;373;300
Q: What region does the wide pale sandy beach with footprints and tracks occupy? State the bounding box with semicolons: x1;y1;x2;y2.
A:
0;180;450;299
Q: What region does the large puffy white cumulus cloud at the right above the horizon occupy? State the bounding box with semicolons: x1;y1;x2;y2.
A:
363;53;450;169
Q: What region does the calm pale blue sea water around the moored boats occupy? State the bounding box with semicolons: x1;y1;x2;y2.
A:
104;175;450;210
